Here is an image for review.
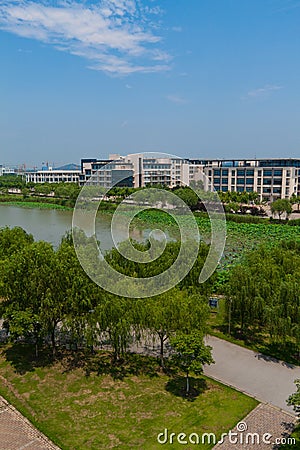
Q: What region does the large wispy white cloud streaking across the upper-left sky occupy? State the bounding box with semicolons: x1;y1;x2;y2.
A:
0;0;171;75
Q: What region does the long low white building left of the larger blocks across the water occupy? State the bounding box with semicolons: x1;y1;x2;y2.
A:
25;164;81;183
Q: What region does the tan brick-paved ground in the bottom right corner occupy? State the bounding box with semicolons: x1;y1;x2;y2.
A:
214;403;296;450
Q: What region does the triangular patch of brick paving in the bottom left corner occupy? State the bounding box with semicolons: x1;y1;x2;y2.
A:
0;396;59;450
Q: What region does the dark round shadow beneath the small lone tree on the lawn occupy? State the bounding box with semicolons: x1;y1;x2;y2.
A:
165;375;208;402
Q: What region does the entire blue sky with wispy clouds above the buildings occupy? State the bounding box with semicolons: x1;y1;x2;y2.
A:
0;0;300;166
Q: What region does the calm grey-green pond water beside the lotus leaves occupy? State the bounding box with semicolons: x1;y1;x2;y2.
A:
0;204;171;250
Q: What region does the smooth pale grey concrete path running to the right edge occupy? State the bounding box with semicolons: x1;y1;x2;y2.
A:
204;336;300;413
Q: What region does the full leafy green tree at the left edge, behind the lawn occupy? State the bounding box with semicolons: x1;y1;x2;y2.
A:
1;241;56;353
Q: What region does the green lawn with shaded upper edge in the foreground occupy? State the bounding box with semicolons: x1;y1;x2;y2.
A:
0;344;257;450
